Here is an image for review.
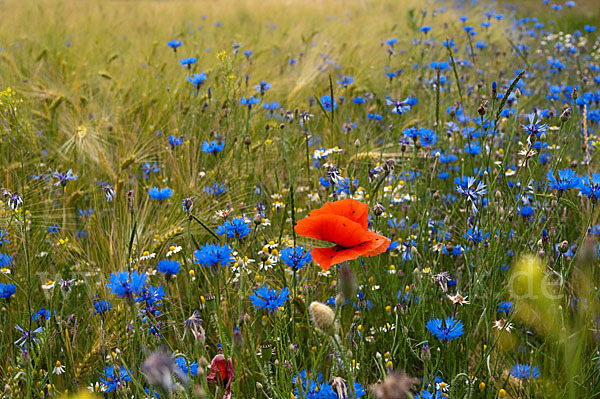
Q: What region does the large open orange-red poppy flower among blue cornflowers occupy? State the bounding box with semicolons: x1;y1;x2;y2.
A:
294;199;391;270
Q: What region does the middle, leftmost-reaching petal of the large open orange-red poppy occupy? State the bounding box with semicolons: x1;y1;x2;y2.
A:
294;214;369;247
